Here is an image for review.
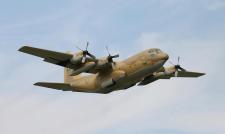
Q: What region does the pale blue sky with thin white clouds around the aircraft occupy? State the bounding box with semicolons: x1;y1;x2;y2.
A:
0;0;225;134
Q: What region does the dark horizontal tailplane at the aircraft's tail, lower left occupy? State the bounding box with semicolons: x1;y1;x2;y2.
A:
34;82;82;92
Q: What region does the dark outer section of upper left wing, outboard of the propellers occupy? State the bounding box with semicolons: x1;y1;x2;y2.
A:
19;46;76;69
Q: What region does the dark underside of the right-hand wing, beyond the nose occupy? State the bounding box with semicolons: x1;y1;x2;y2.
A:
138;71;205;86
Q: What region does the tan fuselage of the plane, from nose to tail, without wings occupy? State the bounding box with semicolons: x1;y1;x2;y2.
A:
71;49;168;93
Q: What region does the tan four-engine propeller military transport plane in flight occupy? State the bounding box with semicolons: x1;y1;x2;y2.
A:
19;43;205;94
